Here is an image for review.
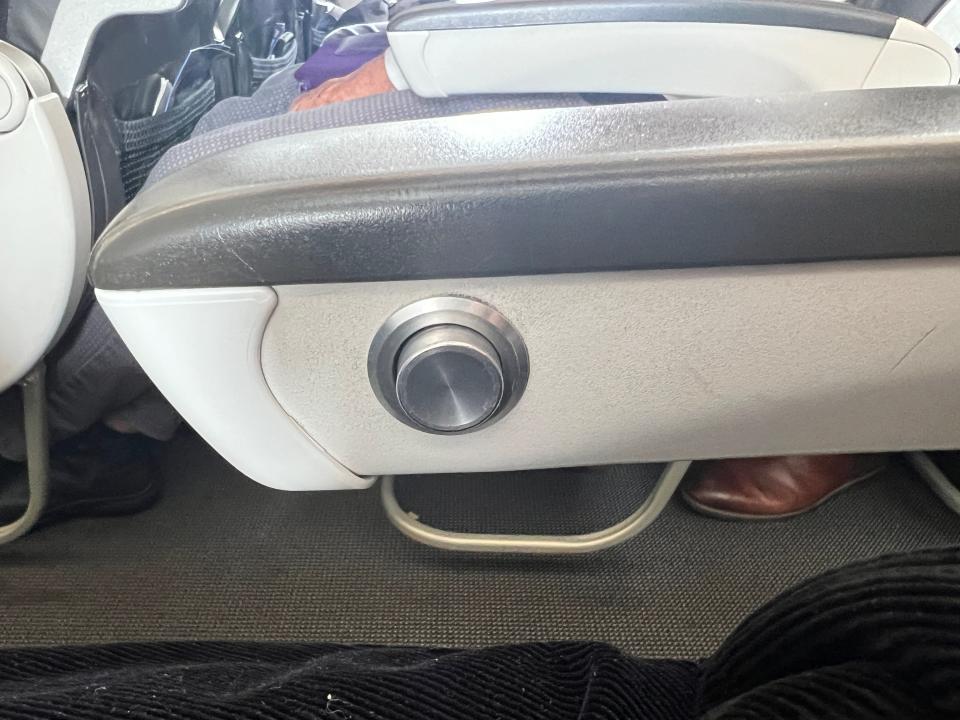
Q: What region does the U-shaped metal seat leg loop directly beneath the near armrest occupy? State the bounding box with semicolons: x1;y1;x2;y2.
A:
380;460;690;555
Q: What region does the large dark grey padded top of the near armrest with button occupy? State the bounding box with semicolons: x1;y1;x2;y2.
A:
91;87;960;289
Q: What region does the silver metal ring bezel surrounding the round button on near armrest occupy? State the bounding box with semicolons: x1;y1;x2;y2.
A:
367;296;530;435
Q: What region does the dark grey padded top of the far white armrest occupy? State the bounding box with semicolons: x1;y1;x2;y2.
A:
389;0;897;38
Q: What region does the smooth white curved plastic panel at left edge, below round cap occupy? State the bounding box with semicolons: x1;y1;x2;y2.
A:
0;93;91;390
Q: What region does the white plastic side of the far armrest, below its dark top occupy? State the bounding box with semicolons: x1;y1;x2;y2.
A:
387;20;957;97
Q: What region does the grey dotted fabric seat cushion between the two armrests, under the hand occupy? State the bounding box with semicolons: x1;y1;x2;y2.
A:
146;68;587;187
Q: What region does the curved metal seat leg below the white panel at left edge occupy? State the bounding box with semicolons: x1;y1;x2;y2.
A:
0;363;50;545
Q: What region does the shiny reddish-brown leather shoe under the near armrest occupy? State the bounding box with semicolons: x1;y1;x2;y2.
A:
681;455;886;520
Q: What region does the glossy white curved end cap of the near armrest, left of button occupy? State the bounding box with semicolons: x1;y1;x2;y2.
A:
97;287;372;490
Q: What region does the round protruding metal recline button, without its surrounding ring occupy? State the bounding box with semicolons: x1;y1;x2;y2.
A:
396;325;504;433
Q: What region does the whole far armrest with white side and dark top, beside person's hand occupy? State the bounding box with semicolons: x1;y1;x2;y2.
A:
387;0;960;97
